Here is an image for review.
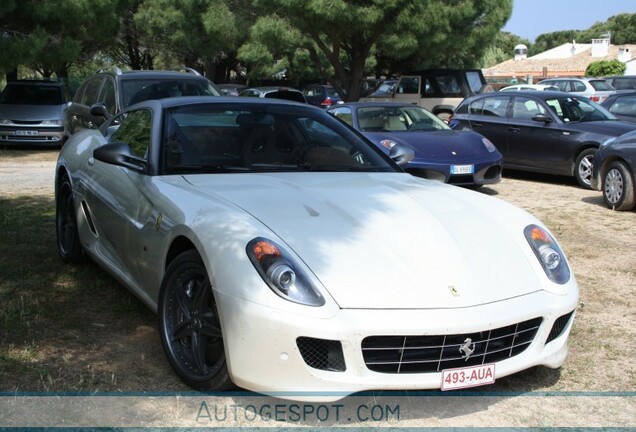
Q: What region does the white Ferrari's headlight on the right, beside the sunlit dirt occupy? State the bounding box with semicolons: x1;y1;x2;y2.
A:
524;225;570;284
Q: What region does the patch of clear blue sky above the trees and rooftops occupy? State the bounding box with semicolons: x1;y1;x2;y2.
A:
503;0;636;42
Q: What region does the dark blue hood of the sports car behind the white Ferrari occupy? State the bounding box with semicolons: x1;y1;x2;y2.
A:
364;130;488;160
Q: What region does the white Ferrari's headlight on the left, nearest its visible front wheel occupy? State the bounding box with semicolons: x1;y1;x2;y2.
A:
247;237;325;306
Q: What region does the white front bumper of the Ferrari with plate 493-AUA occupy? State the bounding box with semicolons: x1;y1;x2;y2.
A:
215;283;578;401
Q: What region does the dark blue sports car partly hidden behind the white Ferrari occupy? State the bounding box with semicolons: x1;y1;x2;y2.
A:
328;102;502;186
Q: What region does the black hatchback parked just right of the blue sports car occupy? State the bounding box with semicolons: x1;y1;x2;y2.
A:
450;91;636;188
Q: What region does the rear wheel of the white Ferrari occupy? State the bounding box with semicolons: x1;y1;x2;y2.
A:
55;175;84;264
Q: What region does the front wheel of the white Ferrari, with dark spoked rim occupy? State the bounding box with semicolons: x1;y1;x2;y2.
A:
158;250;232;391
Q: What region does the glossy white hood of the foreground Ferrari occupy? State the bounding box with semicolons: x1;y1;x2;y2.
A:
185;173;547;309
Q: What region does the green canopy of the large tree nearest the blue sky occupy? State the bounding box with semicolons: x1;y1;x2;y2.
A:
239;0;512;100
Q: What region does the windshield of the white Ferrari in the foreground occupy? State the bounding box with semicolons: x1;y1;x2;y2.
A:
162;104;397;174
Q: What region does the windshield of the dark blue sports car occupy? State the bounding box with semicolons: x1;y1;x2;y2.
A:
358;106;450;132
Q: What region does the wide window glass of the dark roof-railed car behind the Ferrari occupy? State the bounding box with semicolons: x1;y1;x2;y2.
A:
122;78;220;108
